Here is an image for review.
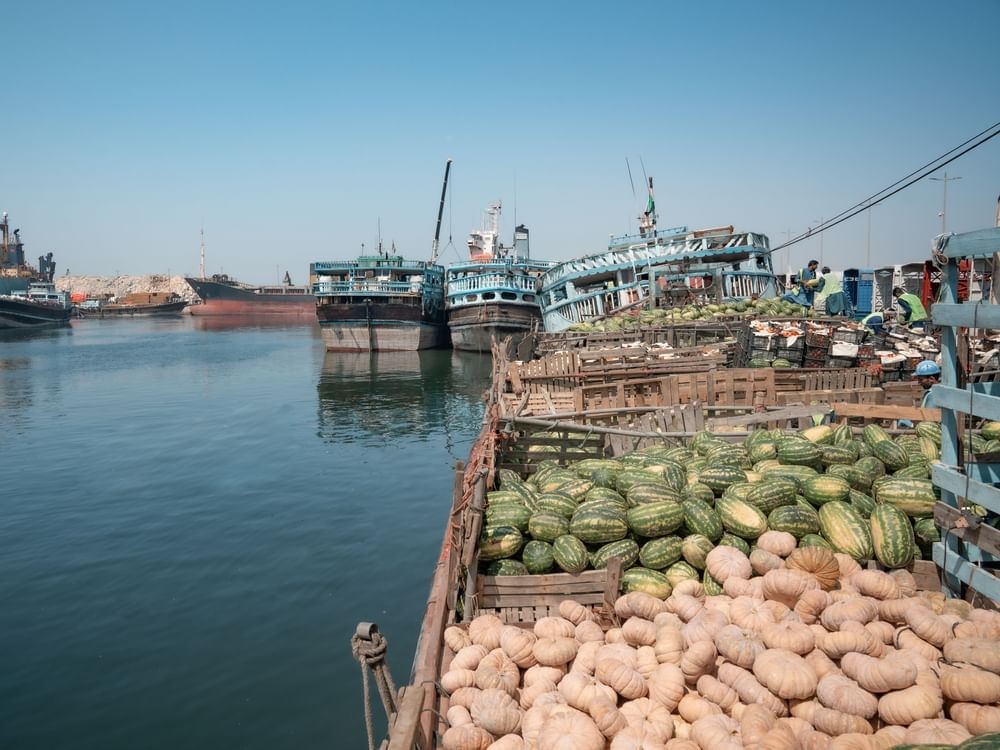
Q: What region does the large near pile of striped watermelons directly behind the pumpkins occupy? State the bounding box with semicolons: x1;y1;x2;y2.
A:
479;422;1000;598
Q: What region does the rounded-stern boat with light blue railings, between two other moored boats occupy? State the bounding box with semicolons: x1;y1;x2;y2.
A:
445;203;555;353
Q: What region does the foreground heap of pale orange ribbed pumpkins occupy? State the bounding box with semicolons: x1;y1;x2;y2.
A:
441;560;1000;750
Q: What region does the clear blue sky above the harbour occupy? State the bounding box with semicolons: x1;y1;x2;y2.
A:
0;0;1000;282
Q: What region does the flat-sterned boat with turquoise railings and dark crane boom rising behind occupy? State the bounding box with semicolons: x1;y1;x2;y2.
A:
311;159;451;351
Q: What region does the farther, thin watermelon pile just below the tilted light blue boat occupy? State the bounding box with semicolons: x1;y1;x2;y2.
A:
569;298;813;333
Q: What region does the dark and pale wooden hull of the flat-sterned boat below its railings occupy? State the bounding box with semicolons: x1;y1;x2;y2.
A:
316;303;448;352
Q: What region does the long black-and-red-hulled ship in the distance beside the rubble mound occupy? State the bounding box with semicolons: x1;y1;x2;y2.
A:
184;273;316;316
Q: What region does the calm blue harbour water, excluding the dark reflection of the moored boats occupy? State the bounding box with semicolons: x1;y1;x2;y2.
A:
0;317;489;750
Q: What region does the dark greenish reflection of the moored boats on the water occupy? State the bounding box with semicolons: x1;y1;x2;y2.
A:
317;350;490;450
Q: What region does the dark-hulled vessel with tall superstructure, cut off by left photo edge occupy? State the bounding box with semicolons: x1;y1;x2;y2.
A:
0;217;73;330
